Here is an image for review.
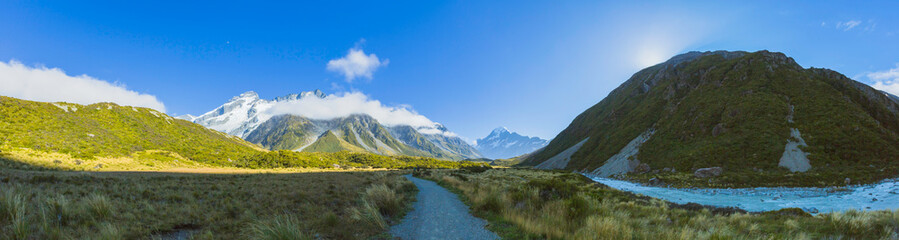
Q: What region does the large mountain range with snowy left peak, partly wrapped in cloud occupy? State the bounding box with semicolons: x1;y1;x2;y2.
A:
191;90;480;160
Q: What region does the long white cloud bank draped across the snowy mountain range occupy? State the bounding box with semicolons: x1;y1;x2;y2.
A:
267;92;455;136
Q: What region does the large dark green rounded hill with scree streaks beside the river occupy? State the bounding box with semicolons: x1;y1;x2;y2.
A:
523;51;899;185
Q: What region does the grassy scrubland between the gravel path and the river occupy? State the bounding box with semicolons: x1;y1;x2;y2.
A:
416;169;899;239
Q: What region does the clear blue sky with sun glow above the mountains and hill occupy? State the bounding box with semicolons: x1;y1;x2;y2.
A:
0;1;899;140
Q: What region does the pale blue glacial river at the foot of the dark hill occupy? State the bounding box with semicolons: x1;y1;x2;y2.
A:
587;176;899;213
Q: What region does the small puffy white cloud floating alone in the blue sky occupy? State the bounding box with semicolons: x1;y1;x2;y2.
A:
327;47;390;82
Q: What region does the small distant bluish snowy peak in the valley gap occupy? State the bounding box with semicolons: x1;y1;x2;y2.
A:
476;127;548;159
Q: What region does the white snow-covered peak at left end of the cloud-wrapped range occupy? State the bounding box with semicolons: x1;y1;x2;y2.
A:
192;90;325;138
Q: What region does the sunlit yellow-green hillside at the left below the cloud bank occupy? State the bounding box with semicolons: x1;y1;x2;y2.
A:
0;96;261;164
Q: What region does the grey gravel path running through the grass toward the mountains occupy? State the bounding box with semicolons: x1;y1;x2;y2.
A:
390;175;499;240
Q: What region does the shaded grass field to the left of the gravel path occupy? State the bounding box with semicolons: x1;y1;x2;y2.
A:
0;164;417;239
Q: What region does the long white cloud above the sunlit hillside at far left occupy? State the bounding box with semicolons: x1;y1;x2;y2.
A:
0;60;165;112
